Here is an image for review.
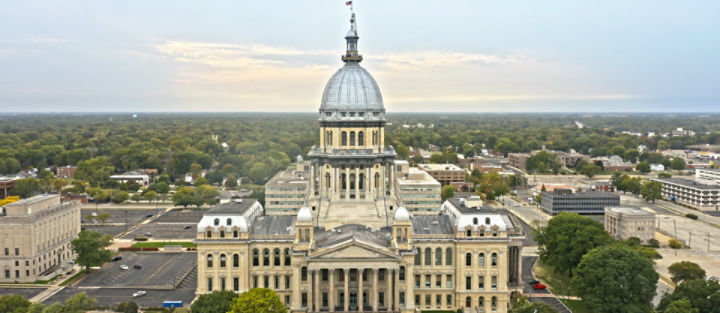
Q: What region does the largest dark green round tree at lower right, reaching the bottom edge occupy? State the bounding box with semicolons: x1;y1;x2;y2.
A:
570;244;659;313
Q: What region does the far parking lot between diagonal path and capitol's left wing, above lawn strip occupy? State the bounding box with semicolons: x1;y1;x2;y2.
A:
118;209;202;239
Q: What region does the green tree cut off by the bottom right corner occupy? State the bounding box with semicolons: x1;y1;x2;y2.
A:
657;279;720;313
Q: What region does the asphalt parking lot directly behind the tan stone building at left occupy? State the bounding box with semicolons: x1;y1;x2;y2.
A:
81;208;157;236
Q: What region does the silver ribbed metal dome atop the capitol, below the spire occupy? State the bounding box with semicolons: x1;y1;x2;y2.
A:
320;62;385;113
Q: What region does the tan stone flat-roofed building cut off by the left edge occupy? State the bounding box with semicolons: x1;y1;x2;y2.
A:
0;195;81;282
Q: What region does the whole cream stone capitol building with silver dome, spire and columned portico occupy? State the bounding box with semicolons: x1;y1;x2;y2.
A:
196;9;525;313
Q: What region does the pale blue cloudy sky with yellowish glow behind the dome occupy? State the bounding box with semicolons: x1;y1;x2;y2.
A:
0;0;720;112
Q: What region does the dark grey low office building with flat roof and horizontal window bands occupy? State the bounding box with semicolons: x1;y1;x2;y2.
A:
541;189;620;215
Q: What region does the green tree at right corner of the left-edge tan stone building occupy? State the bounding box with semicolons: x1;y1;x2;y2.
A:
70;230;112;271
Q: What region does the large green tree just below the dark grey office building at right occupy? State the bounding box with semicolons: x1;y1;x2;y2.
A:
535;213;612;276
